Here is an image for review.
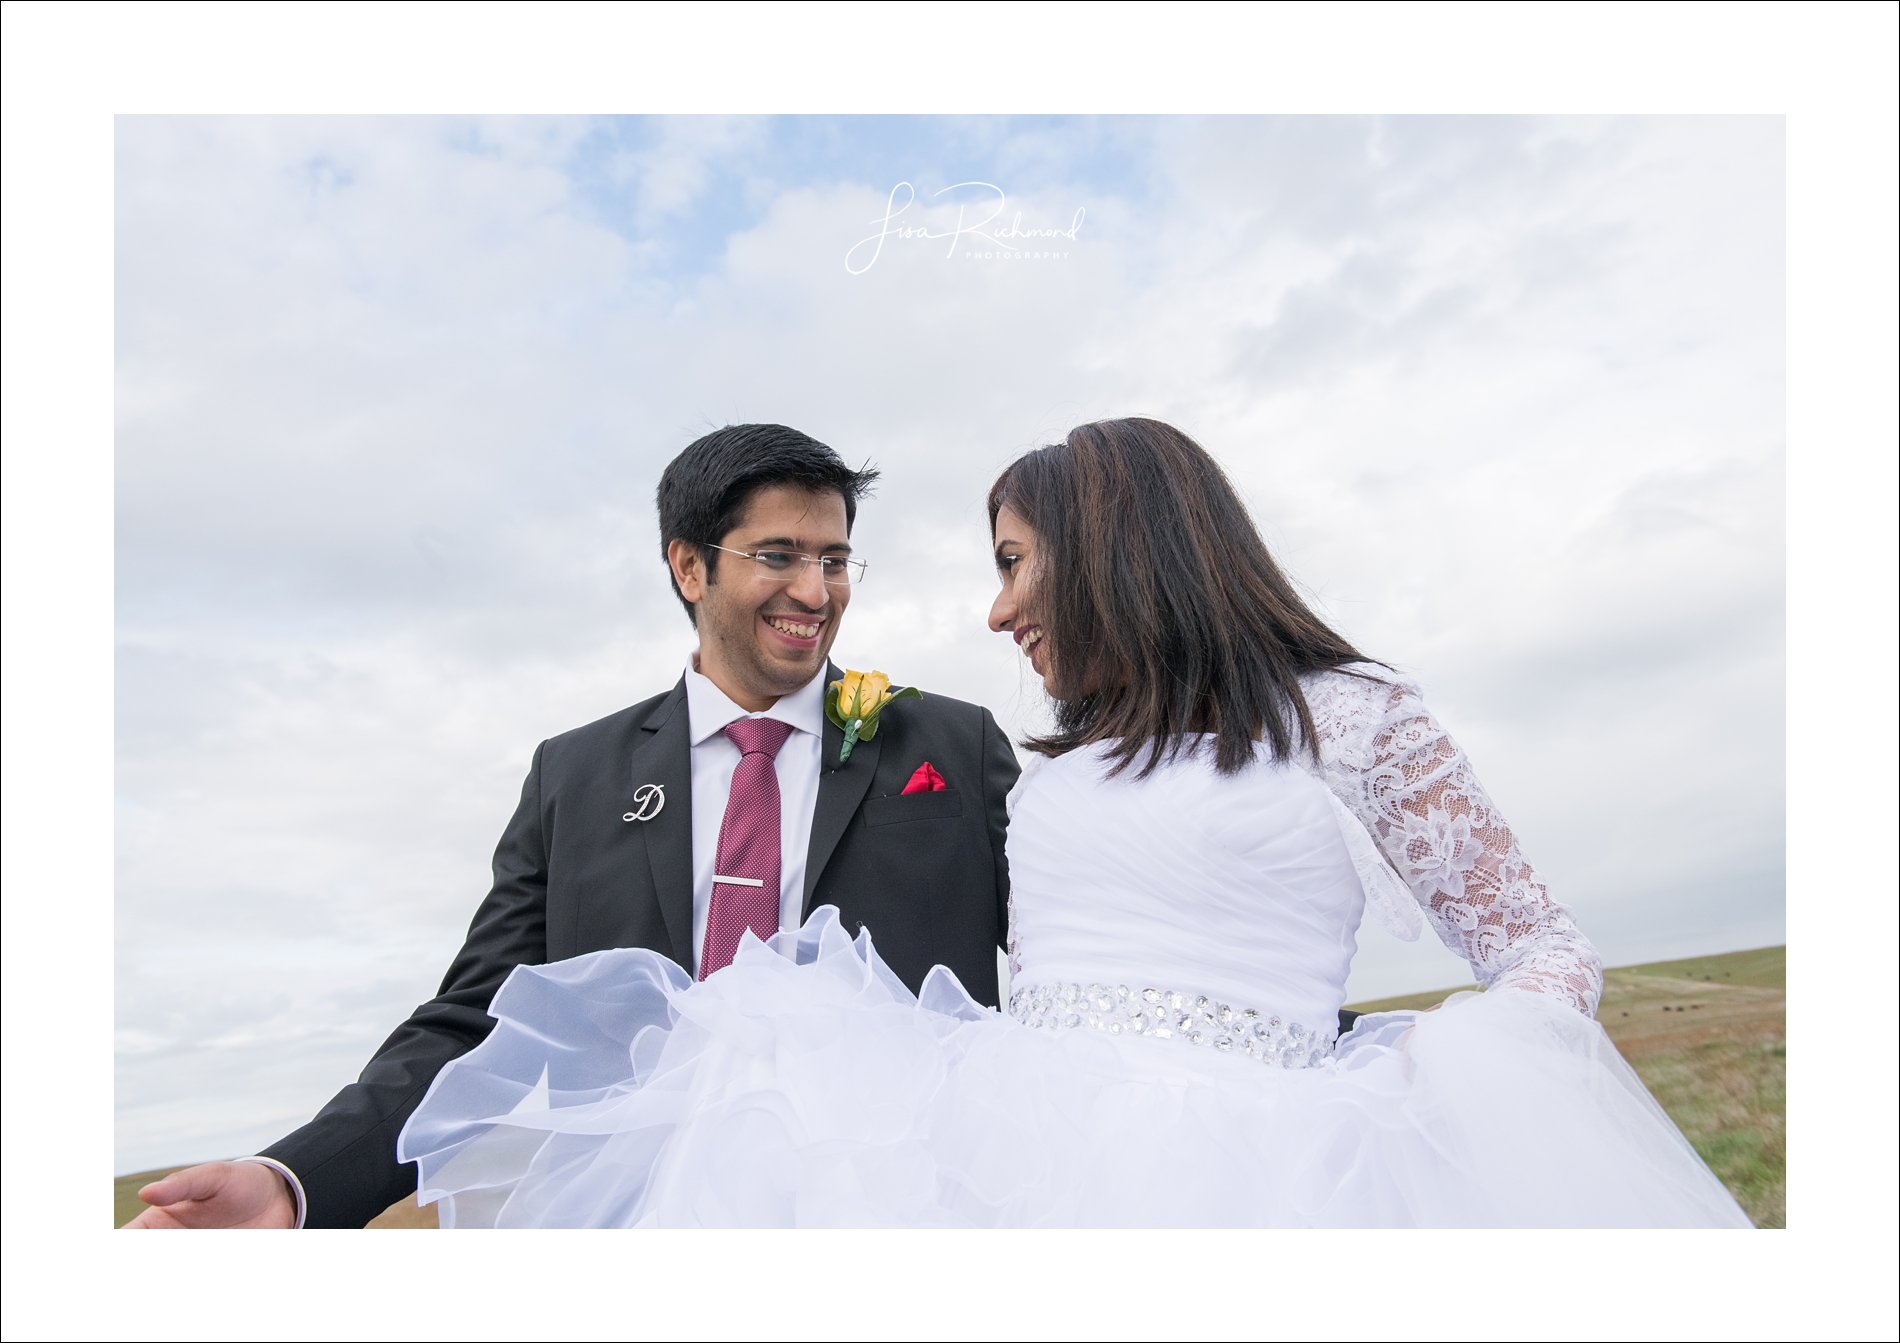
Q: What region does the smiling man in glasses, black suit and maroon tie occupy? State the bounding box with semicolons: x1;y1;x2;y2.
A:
131;424;1017;1227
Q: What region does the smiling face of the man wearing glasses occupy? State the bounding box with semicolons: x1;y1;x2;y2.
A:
667;484;851;712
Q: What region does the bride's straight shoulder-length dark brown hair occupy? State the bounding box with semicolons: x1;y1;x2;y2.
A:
990;420;1366;777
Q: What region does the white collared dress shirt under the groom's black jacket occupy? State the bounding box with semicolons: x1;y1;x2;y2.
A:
686;653;825;961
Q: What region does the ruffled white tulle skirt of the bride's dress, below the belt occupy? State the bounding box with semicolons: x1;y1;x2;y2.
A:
397;908;1748;1227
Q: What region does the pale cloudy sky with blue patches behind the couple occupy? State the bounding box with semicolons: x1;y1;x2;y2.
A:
116;118;1784;1170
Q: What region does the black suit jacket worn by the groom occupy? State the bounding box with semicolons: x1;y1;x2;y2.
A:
262;667;1018;1227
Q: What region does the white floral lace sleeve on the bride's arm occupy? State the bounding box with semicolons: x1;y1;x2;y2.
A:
1305;667;1604;1016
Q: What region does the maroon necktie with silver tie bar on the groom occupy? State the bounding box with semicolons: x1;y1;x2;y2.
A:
699;718;792;978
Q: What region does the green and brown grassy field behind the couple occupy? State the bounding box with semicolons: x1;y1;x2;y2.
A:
112;946;1788;1231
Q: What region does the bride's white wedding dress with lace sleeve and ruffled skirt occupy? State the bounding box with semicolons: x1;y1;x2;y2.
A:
397;667;1748;1227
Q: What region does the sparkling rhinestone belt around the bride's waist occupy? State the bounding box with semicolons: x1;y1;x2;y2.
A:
1009;984;1334;1068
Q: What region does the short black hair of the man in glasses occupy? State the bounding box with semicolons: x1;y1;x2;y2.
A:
657;424;878;627
